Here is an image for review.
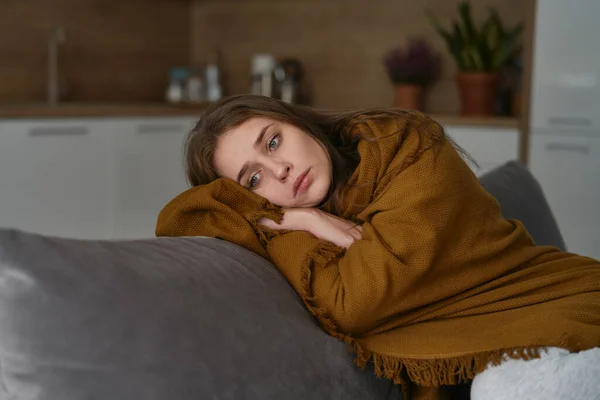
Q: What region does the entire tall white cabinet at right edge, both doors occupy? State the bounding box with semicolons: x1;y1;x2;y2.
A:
529;0;600;258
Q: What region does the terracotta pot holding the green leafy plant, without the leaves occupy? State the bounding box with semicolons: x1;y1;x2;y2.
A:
456;72;500;116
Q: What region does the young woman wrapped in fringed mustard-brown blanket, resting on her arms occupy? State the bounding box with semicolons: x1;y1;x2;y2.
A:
156;96;600;400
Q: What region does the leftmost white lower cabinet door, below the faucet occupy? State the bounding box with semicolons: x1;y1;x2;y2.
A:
0;119;111;239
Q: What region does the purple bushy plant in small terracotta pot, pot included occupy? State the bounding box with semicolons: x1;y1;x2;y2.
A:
383;39;440;110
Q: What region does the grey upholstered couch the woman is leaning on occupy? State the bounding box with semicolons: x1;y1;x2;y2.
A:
0;162;565;400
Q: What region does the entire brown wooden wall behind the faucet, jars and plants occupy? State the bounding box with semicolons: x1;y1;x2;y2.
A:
0;0;526;109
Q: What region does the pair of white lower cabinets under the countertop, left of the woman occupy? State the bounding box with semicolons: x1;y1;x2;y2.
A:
0;117;194;239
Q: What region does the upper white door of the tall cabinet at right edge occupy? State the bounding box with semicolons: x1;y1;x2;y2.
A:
531;0;600;132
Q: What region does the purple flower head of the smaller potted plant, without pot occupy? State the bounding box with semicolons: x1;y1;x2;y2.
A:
383;39;441;86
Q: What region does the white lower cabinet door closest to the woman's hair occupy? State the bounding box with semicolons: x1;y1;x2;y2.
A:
113;117;194;239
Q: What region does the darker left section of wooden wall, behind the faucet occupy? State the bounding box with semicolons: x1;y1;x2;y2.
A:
0;0;190;103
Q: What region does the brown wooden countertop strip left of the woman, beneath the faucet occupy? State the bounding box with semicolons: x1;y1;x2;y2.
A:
0;103;208;118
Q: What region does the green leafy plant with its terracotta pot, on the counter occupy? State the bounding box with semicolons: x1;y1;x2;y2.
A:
429;1;523;116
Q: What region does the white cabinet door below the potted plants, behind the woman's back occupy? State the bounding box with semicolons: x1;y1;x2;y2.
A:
444;126;519;175
